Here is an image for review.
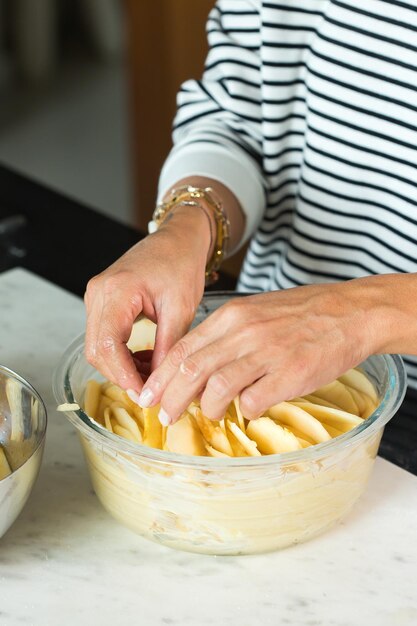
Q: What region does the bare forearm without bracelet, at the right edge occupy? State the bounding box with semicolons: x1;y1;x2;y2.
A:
344;274;417;355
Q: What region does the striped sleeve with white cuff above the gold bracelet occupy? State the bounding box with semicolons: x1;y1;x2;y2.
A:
159;0;267;241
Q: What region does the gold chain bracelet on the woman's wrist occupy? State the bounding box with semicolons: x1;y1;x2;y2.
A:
148;185;230;285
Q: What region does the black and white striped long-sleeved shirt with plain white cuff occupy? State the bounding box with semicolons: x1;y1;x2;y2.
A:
160;0;417;387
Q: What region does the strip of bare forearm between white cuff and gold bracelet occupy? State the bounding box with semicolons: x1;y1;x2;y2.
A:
158;176;245;255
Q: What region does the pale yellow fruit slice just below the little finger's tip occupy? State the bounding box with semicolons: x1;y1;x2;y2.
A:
246;417;302;454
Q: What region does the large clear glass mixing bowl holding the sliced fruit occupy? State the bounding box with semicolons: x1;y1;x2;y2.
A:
54;293;406;555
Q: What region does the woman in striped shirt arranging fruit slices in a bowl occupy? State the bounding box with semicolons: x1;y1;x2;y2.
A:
85;0;417;425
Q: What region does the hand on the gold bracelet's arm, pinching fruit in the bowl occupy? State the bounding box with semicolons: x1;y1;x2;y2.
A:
84;207;210;401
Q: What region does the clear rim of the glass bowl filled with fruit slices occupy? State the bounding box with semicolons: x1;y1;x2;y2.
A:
52;291;407;470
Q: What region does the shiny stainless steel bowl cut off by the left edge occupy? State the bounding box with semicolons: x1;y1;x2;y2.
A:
0;365;47;537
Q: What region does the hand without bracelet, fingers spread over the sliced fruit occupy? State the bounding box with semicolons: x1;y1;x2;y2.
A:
139;279;379;425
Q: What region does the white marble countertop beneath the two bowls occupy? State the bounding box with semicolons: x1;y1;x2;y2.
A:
0;269;417;626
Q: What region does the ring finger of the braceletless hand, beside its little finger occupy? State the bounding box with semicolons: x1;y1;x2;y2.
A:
200;354;266;420
